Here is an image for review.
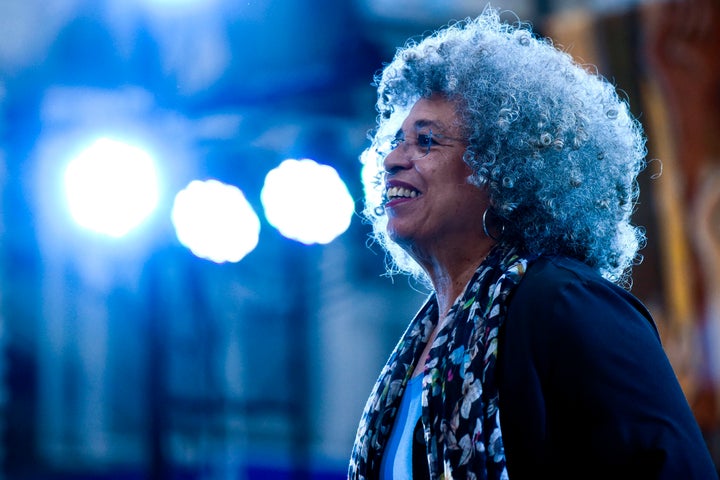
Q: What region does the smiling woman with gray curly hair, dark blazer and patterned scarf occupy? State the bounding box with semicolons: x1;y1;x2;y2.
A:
349;9;716;480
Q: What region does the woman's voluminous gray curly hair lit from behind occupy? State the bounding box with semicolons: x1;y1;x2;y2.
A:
361;7;646;283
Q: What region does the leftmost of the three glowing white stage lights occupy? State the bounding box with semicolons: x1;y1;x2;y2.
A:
65;138;159;237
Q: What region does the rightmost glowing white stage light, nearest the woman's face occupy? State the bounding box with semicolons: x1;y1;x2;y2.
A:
260;159;355;245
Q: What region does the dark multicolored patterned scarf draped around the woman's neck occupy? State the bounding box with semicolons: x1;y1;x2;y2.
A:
348;246;528;480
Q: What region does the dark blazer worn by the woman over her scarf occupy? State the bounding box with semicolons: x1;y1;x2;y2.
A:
497;257;718;480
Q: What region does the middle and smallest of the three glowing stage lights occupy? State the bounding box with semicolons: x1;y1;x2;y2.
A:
172;180;260;263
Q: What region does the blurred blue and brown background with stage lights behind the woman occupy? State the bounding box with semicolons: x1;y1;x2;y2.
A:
0;0;720;480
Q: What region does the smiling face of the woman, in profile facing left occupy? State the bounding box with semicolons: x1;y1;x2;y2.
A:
384;96;489;258
